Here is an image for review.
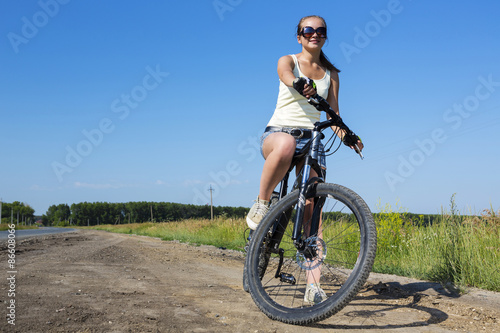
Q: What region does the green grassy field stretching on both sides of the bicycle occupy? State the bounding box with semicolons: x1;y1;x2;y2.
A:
84;206;500;291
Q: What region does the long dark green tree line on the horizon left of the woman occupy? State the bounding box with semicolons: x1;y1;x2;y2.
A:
42;201;249;226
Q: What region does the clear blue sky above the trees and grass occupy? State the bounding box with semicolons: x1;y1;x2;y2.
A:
0;0;500;214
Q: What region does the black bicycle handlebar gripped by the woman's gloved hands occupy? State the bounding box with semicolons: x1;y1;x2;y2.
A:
293;77;363;159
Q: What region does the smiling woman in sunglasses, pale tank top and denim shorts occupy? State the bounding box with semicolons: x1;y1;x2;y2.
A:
246;15;363;302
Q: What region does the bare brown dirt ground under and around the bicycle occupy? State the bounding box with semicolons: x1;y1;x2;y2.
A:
0;230;500;333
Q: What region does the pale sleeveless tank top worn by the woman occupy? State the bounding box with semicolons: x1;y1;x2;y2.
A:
267;54;330;129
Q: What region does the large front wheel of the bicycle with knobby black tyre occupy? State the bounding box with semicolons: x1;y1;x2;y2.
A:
246;184;377;325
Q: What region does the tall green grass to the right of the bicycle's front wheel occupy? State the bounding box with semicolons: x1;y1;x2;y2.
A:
373;199;500;291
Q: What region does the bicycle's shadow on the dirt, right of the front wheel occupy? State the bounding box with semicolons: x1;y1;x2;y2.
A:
311;282;459;330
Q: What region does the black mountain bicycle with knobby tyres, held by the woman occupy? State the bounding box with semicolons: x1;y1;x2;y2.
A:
243;78;377;325
